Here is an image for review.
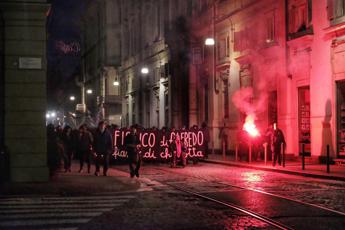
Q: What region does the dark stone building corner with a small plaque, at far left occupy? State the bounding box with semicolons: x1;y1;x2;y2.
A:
0;0;49;182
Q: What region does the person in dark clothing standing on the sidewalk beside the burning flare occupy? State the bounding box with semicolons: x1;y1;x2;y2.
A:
271;123;286;166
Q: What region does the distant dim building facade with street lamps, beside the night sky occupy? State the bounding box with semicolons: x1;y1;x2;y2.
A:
79;0;122;125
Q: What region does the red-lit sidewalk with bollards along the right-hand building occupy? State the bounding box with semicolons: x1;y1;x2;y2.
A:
203;154;345;181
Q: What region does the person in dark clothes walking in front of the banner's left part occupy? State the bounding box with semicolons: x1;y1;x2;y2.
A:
125;126;141;178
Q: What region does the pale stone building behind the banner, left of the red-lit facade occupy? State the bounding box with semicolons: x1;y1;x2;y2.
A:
118;0;193;128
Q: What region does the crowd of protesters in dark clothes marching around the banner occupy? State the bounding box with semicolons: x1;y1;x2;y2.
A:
47;121;209;177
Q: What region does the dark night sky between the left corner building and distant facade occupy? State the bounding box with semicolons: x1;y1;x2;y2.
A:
47;0;85;107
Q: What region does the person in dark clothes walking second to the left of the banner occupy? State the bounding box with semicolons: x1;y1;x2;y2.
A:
77;124;93;173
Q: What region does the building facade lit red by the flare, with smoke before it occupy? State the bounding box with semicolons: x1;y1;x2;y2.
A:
189;0;345;160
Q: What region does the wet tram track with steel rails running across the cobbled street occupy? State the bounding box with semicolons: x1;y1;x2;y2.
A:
143;168;345;229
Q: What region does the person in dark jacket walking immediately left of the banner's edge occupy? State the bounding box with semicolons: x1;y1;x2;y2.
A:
93;121;113;176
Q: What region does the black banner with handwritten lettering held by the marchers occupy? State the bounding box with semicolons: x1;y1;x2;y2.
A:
113;129;205;161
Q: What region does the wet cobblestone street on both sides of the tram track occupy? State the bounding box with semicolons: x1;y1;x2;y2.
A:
81;163;345;229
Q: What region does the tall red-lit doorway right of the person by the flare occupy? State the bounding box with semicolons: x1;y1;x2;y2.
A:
298;87;311;156
